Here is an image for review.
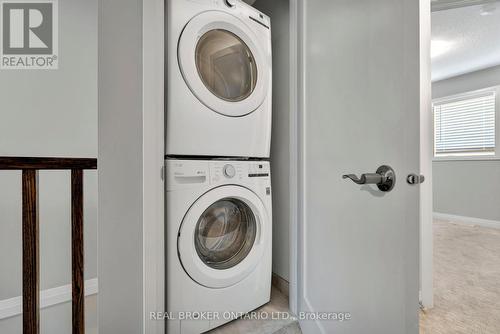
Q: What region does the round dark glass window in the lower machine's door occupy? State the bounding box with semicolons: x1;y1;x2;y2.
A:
194;198;257;270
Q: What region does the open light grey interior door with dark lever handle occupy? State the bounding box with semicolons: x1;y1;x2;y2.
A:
296;0;420;334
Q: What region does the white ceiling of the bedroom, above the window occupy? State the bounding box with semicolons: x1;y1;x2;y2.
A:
431;0;500;81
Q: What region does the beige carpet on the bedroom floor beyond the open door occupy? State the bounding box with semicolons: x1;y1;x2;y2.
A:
420;221;500;334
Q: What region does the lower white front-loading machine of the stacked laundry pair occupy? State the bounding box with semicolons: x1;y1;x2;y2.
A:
166;159;272;334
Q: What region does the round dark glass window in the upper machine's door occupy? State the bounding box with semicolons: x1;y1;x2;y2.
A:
195;29;257;102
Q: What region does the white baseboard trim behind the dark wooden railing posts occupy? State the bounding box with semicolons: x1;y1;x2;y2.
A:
0;278;99;320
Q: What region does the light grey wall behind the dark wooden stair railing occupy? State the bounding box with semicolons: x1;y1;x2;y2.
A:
0;0;97;334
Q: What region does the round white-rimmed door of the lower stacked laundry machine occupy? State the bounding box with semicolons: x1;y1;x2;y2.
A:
177;186;269;288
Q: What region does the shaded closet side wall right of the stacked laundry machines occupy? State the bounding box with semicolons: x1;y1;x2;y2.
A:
254;0;290;280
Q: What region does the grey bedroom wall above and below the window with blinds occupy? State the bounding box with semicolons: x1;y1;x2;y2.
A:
432;66;500;221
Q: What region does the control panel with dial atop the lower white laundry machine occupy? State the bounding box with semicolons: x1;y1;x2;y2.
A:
165;159;271;190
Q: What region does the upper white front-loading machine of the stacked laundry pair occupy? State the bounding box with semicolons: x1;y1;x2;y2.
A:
166;0;272;158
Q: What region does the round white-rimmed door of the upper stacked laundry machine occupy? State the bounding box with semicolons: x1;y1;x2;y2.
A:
178;11;270;117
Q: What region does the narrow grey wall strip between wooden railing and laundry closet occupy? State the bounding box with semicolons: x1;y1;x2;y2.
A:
98;0;144;334
